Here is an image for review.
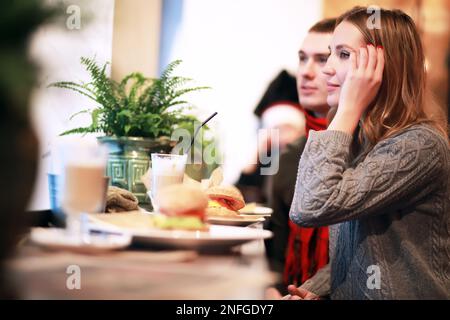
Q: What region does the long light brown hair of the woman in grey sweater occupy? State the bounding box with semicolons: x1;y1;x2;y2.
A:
336;7;448;146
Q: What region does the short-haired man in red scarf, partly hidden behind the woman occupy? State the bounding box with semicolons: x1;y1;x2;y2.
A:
266;19;336;291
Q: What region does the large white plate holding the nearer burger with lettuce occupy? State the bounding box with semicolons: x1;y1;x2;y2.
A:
87;218;272;250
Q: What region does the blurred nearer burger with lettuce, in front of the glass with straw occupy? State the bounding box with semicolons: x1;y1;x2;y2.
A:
154;184;209;231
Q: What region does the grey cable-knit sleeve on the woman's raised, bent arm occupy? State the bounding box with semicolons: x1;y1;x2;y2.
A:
289;126;449;227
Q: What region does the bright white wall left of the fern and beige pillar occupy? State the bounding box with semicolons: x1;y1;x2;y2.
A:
29;0;114;210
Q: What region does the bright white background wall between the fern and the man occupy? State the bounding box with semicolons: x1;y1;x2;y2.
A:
161;0;322;183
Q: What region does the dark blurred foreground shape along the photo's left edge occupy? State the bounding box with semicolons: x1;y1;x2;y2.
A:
0;0;52;298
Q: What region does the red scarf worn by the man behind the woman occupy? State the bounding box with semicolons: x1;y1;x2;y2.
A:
283;110;328;285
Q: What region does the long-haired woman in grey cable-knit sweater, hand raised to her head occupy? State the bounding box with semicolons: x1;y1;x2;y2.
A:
278;7;450;299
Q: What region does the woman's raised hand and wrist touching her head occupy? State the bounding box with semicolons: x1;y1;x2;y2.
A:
328;45;384;134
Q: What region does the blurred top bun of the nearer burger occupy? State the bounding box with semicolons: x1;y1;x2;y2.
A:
155;184;208;218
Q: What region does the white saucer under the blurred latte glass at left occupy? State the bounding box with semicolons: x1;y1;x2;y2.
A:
30;228;131;253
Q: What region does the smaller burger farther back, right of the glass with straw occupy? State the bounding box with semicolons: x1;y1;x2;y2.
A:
206;186;245;217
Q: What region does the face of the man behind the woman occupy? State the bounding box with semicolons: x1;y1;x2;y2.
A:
297;32;332;116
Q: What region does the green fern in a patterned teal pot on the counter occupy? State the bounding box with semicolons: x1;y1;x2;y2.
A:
50;57;207;205
